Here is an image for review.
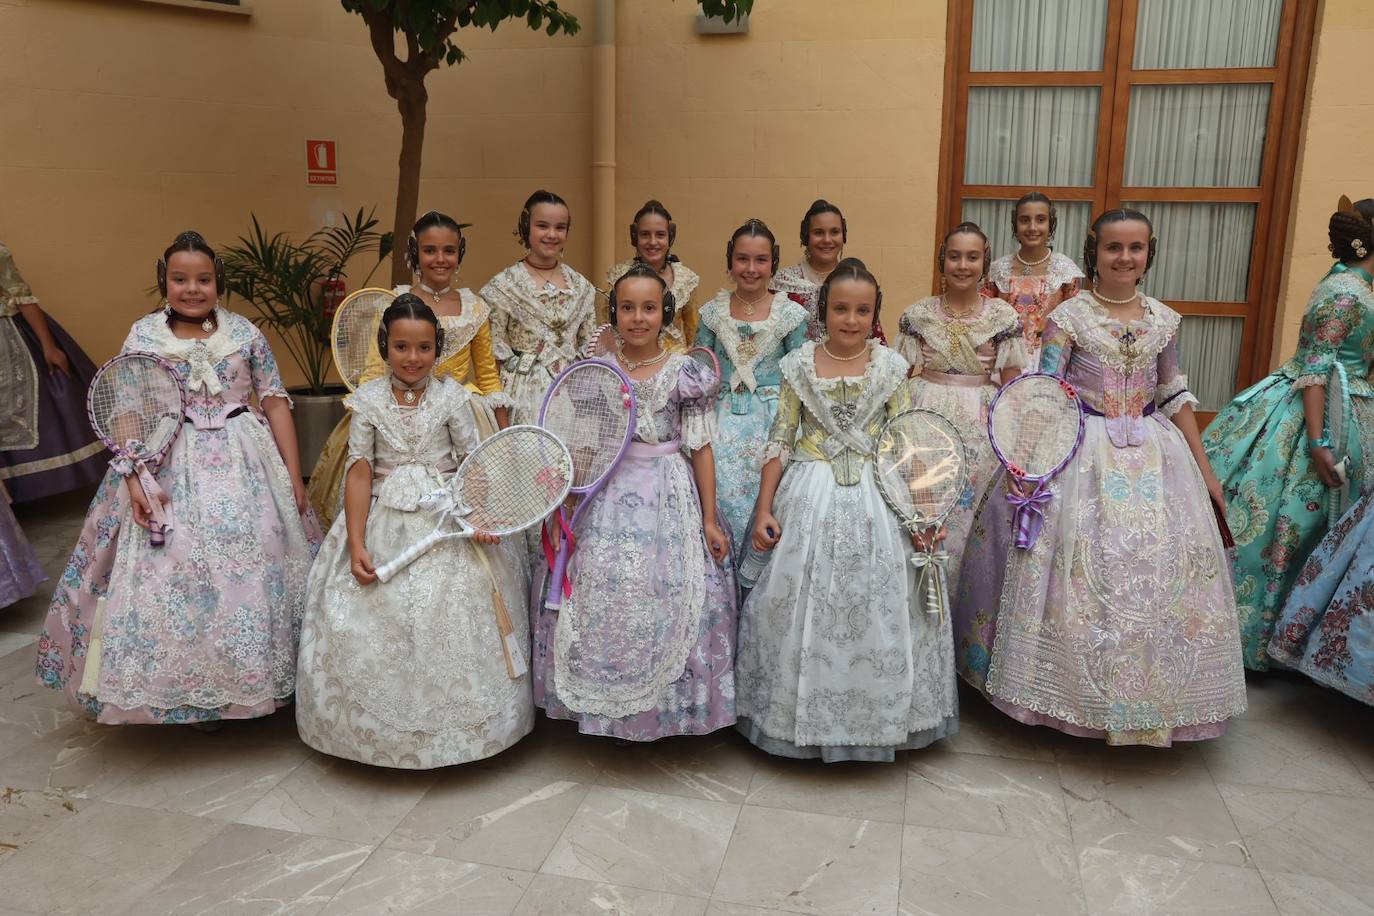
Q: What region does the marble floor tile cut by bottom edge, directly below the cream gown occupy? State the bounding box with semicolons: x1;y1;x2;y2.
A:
322;849;533;916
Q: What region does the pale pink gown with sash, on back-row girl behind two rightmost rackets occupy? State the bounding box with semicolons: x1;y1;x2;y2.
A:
897;297;1026;592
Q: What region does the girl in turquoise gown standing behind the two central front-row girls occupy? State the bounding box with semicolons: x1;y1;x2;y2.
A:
697;220;807;551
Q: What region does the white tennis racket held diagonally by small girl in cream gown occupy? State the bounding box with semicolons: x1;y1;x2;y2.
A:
376;426;573;582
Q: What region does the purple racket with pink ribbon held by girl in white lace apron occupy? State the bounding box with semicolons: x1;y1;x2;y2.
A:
539;360;635;610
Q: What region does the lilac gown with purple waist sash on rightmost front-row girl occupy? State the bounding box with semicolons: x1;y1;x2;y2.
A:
978;293;1245;746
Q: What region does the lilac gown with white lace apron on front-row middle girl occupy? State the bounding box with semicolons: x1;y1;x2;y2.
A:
530;353;738;742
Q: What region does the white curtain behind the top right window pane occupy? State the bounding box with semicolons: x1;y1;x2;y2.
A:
1132;0;1283;70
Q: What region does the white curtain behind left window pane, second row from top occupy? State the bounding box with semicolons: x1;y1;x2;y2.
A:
963;87;1099;187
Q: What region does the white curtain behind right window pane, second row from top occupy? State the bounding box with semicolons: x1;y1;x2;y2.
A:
1124;82;1271;188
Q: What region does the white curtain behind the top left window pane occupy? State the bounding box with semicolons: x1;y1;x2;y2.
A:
972;0;1107;73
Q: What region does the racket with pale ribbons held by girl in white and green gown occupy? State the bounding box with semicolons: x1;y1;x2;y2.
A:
874;408;969;619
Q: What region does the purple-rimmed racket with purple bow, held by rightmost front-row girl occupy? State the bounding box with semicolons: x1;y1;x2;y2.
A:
988;372;1083;551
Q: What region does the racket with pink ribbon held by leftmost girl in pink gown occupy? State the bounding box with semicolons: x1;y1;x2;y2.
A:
87;353;185;547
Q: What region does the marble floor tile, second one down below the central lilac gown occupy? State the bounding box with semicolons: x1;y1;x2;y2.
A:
540;786;739;897
